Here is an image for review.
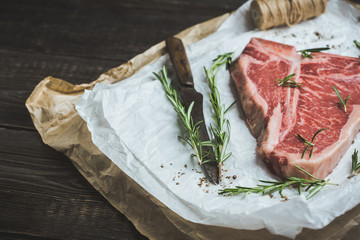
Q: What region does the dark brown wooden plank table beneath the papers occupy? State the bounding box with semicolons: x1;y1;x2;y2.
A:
0;0;244;239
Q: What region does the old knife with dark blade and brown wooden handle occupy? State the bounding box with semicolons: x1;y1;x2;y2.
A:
165;37;219;184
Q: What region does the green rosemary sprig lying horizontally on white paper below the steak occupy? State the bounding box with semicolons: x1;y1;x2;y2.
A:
219;165;337;200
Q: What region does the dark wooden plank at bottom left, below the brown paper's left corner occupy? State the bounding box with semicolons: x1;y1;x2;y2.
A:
0;129;146;239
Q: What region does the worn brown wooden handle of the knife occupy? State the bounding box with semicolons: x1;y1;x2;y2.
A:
166;37;194;87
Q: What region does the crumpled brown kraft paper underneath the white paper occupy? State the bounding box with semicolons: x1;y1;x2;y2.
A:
26;6;360;239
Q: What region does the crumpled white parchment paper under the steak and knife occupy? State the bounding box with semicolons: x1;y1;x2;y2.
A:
76;0;360;238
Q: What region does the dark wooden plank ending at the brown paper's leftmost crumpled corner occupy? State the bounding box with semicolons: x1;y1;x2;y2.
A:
0;50;121;130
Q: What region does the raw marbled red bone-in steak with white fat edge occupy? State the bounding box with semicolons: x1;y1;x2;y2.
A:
230;38;360;179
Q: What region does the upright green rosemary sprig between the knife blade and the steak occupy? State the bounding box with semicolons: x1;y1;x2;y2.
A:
204;52;235;177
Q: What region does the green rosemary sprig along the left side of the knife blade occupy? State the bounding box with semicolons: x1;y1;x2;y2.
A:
154;66;212;165
